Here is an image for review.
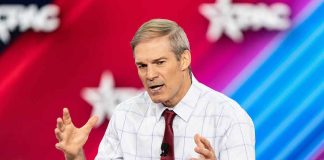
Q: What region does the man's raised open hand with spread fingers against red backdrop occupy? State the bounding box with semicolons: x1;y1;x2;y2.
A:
55;108;98;160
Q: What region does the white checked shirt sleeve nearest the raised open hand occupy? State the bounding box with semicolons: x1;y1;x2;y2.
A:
95;114;123;160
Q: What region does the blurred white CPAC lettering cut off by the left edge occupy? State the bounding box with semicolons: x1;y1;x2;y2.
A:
0;4;59;43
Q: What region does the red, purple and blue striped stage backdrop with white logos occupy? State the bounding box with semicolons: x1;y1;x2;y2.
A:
0;0;324;160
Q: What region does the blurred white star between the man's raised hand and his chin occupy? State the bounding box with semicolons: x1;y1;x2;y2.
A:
81;71;143;127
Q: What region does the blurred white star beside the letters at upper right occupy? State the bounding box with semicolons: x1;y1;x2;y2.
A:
199;0;243;42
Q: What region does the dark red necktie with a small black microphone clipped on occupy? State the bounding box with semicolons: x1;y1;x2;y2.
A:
161;109;176;160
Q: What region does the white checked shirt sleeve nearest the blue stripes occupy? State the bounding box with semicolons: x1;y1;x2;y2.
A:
219;102;255;160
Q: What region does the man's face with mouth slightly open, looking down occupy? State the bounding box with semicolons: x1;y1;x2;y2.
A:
134;36;190;107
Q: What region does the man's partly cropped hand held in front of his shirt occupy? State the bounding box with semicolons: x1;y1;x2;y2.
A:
192;134;216;160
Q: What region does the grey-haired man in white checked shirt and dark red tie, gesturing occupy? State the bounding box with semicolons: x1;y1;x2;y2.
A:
55;19;255;160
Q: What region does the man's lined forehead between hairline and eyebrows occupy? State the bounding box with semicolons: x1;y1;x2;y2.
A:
134;36;175;61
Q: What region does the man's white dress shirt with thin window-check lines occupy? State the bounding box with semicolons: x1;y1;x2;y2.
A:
96;77;255;160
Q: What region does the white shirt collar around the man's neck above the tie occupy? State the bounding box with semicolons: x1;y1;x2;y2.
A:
153;76;201;122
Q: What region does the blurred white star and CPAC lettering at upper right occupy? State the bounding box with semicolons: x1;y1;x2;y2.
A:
199;0;290;42
